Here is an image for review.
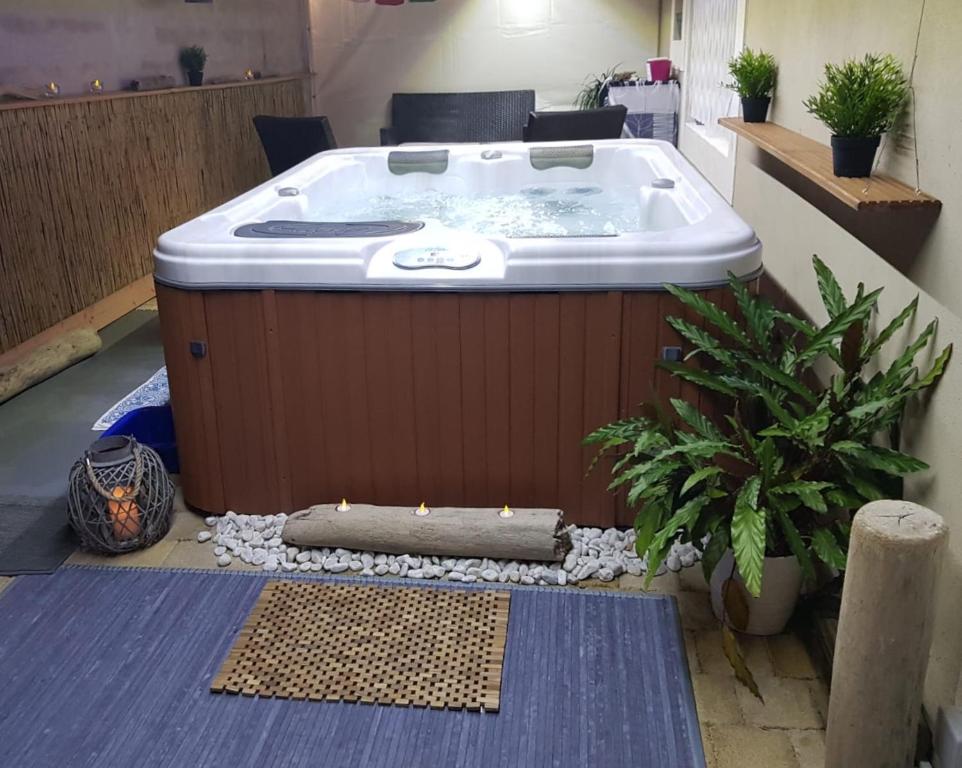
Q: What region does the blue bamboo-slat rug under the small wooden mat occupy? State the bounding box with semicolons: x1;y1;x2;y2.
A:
0;566;705;768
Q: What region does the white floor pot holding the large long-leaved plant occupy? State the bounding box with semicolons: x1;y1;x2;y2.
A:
711;549;802;635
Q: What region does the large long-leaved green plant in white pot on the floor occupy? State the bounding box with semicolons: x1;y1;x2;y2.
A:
586;257;952;690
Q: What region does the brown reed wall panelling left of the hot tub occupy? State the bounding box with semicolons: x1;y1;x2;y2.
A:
0;78;306;353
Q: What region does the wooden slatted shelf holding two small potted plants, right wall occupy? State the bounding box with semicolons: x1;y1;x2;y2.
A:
718;117;942;210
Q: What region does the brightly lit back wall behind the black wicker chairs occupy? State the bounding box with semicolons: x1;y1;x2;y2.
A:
310;0;659;146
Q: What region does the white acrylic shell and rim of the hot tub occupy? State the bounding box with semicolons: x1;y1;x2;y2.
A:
154;139;761;291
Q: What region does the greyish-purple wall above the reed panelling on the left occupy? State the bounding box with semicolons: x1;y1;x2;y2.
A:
0;0;307;95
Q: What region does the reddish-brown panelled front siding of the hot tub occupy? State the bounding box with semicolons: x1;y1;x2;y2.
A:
157;286;727;525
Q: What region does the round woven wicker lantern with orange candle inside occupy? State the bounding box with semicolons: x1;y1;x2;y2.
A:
67;435;174;555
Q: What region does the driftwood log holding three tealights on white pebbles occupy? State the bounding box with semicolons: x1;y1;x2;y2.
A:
283;504;571;561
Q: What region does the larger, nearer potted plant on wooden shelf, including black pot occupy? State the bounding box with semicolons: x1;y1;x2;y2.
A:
804;53;909;177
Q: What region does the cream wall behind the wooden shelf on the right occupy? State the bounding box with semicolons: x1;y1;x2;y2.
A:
712;0;962;728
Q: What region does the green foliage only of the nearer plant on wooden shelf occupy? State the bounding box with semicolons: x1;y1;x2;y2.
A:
804;53;909;138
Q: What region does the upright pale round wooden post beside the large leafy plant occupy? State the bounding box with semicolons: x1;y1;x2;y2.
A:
825;501;948;768
